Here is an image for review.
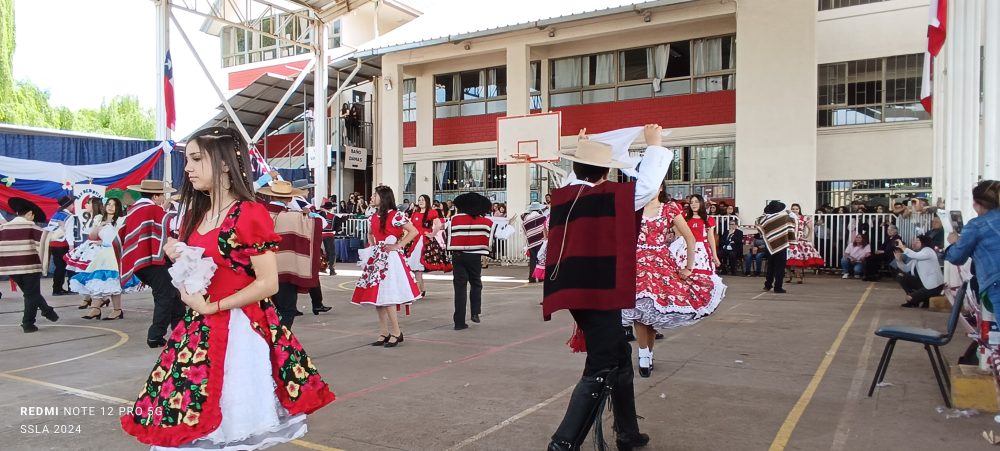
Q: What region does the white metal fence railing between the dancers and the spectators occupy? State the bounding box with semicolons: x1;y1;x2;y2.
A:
344;213;933;269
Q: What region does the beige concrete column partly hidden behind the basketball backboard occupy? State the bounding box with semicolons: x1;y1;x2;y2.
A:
507;44;532;216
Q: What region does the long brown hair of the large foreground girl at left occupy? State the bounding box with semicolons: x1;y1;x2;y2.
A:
180;127;253;241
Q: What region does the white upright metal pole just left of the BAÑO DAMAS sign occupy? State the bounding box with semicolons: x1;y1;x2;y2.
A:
313;18;330;204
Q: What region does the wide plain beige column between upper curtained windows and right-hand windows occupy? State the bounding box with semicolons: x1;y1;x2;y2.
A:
736;0;817;222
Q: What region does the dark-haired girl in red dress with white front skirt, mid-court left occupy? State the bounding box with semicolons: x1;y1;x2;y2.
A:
351;186;420;348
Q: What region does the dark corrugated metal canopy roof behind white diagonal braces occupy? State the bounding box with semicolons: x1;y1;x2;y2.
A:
201;58;382;136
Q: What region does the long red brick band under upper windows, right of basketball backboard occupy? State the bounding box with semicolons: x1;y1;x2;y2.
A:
556;91;736;136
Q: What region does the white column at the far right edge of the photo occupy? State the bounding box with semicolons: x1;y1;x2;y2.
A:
983;0;1000;180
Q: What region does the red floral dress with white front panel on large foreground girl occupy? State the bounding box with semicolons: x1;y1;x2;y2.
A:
121;202;335;450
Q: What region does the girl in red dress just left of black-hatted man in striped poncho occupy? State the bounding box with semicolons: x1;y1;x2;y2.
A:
406;194;451;296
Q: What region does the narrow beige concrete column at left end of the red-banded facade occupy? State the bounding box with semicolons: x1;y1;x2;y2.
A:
376;55;404;196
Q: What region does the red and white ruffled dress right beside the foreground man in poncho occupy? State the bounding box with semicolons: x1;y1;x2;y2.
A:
622;202;725;330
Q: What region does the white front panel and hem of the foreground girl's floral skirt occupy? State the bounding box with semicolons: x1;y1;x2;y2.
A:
150;309;307;451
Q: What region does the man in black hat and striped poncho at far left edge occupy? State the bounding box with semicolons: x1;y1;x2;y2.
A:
0;197;59;333
